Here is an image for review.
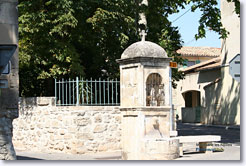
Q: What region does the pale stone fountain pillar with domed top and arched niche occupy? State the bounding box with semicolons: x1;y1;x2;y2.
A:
117;40;179;160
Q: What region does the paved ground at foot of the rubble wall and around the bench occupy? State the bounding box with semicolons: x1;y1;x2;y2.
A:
16;124;240;160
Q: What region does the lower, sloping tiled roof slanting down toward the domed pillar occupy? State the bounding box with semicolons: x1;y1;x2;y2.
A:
180;57;221;73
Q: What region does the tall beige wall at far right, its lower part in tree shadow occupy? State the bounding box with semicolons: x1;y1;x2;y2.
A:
202;0;240;125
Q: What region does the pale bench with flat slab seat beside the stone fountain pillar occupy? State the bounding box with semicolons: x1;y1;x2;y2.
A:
177;135;221;156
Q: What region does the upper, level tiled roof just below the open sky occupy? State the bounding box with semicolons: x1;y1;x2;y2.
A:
177;47;221;57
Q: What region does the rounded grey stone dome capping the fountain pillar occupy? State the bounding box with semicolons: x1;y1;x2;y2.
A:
121;41;168;59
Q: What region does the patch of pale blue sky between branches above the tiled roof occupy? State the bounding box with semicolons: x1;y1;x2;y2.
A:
169;3;221;48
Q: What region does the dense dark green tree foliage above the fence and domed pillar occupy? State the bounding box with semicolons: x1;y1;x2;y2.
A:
18;0;240;96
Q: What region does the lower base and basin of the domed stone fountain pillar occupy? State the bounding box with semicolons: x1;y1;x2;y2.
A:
121;107;179;160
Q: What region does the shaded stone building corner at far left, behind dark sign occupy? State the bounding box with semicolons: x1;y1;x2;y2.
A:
0;0;19;160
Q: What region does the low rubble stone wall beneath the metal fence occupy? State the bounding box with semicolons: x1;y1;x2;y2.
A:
13;97;121;154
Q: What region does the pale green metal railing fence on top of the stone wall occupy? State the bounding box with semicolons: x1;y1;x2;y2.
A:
55;77;120;106
